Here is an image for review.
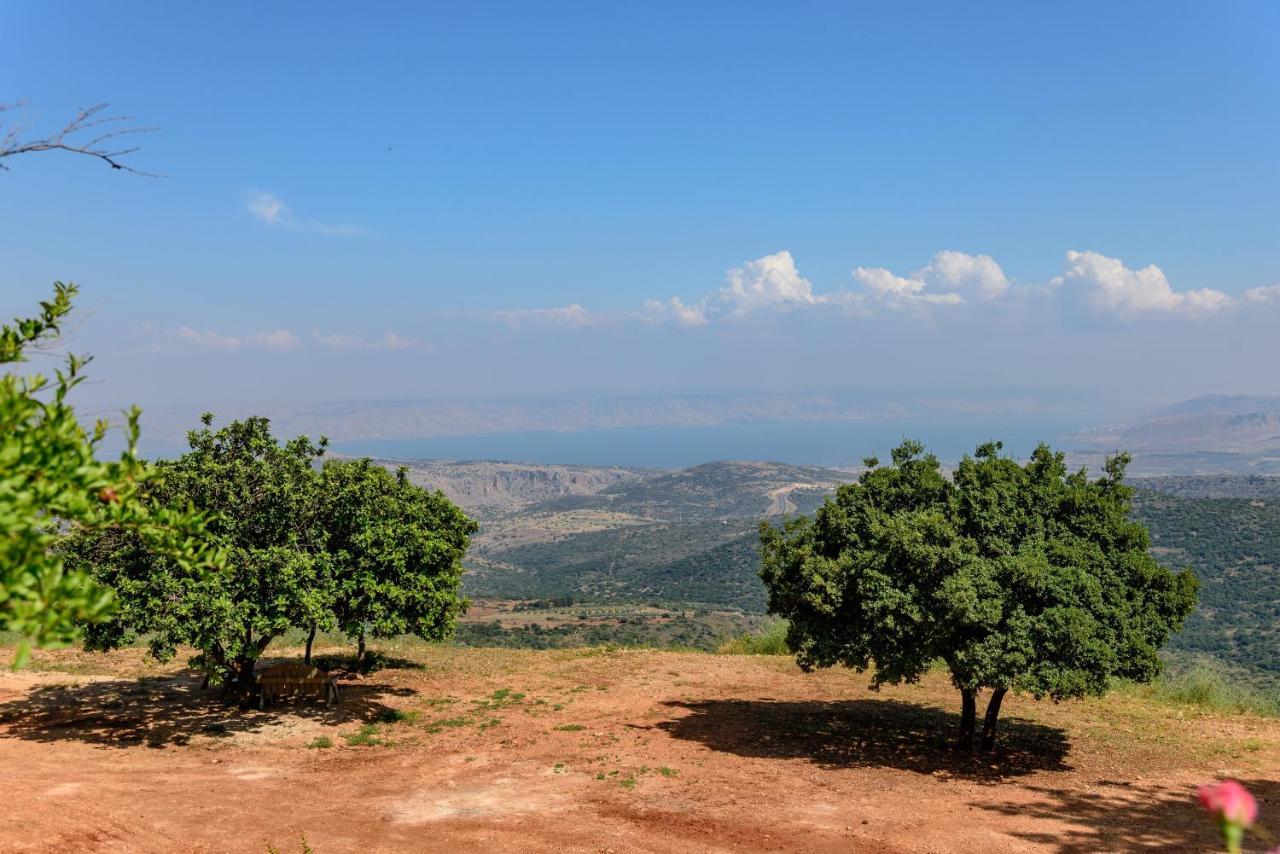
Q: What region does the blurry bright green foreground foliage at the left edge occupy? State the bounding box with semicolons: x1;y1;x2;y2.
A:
0;282;220;667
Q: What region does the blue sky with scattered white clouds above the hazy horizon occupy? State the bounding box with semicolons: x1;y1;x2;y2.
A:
0;3;1280;412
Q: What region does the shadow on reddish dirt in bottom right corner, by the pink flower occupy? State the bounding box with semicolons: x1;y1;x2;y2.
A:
974;780;1280;854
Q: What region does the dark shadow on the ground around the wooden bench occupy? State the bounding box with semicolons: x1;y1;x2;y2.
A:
0;673;417;748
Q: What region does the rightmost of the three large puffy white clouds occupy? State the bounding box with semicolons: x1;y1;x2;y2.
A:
1053;250;1236;318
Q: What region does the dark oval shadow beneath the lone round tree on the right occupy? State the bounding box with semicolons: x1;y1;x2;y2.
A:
657;699;1070;781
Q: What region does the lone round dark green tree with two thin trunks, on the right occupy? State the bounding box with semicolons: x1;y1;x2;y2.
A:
760;442;1197;749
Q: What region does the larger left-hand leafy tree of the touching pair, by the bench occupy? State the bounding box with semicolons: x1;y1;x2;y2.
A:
68;414;332;686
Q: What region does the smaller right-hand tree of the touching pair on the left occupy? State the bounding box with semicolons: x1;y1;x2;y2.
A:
320;460;477;666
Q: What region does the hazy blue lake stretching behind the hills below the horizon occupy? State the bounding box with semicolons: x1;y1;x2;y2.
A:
325;415;1083;469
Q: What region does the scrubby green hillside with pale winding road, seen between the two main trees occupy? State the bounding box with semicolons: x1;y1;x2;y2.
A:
463;462;852;613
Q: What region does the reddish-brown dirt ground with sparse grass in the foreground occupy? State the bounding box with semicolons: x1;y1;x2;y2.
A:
0;647;1280;854
